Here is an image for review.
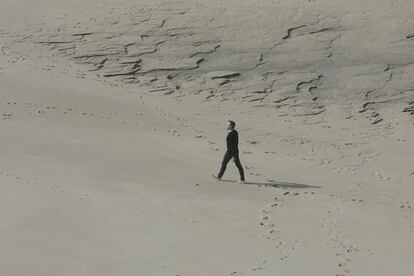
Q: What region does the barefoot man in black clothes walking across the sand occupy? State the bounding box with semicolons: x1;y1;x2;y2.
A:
213;120;245;184
